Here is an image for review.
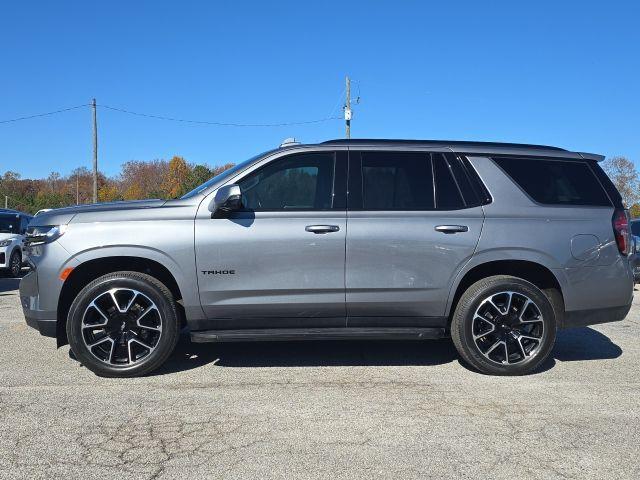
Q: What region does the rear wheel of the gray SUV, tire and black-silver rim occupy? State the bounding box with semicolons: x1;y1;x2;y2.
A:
451;275;557;375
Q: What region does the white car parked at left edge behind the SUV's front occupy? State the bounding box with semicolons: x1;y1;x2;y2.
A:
0;209;33;278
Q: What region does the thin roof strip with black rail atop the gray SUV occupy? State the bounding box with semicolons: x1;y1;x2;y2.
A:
312;138;604;161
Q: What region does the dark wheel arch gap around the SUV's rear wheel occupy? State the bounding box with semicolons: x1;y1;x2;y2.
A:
446;259;564;325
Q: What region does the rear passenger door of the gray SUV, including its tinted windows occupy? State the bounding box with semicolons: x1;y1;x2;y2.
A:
345;150;484;327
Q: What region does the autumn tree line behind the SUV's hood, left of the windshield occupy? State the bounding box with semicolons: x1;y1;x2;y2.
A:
0;156;234;214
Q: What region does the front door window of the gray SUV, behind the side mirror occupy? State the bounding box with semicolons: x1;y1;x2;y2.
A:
238;153;335;211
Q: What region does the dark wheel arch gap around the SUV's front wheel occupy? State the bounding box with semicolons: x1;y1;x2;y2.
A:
56;255;185;347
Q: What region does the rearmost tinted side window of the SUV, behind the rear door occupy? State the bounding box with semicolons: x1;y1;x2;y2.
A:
493;158;611;207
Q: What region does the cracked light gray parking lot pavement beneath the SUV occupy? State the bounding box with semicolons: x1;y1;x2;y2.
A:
0;278;640;479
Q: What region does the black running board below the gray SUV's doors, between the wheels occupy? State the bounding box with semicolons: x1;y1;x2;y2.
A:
191;327;446;343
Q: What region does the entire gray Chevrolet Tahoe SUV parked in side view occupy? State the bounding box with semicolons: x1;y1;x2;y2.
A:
20;140;633;377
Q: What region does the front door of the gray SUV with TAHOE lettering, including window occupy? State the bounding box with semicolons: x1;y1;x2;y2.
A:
195;151;346;329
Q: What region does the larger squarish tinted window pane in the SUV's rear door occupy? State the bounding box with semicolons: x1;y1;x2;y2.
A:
362;152;434;210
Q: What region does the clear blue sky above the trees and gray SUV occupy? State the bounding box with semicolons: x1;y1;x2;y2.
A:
0;0;640;178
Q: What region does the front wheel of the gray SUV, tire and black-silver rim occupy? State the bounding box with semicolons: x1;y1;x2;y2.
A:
66;271;179;377
